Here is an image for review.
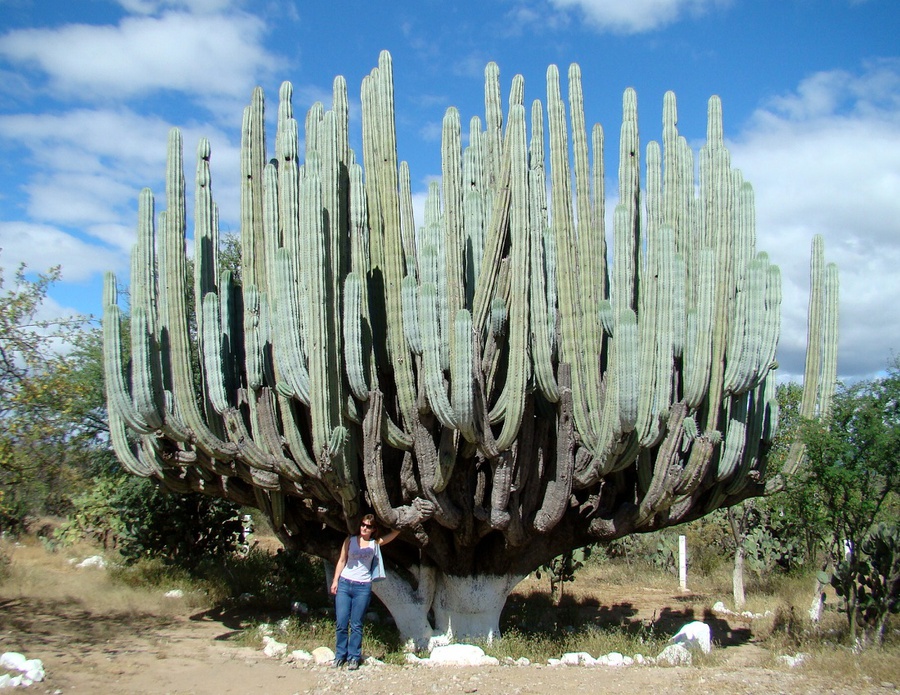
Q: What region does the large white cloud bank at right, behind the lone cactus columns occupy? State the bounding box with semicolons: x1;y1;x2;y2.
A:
731;61;900;376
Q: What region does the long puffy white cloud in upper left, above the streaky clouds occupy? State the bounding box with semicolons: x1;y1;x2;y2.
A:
0;10;278;101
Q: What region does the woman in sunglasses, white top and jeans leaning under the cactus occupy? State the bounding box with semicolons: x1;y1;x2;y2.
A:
331;514;400;671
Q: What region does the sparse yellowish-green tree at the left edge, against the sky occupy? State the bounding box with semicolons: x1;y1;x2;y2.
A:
0;258;98;529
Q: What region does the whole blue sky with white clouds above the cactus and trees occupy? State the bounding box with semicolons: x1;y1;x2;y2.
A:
0;0;900;378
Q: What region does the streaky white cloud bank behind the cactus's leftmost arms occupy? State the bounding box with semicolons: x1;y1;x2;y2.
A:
0;103;240;282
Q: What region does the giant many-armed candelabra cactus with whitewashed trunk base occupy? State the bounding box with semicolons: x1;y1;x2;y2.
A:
104;53;837;640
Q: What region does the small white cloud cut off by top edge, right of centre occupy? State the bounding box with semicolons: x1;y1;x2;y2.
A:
550;0;728;34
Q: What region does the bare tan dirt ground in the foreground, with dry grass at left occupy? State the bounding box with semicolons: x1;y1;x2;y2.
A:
0;554;895;695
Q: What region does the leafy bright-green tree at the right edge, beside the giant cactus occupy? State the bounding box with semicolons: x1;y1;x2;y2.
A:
801;360;900;643
